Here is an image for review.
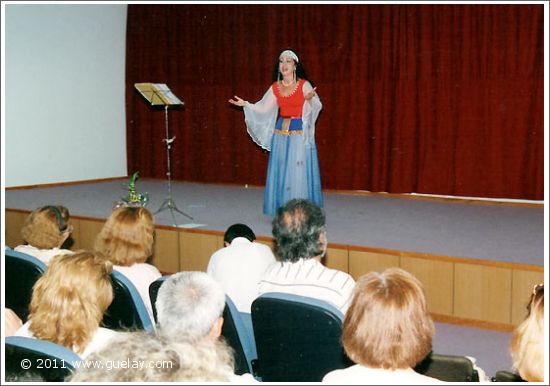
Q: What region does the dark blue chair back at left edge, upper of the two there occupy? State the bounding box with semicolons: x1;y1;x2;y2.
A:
6;248;46;322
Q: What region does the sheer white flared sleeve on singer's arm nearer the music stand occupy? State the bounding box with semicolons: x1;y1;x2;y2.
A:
243;87;279;151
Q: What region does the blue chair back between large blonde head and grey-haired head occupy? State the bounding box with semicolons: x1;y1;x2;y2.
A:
102;271;155;333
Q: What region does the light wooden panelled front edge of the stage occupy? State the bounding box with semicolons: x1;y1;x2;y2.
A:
5;208;544;332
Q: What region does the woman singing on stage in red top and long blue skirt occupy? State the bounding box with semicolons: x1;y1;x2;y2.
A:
229;50;323;217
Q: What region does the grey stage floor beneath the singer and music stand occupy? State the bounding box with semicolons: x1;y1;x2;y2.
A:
5;179;546;266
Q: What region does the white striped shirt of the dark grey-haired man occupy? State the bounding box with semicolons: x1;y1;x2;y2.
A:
258;259;355;314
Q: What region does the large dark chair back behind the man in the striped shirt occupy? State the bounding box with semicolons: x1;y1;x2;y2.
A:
252;292;353;382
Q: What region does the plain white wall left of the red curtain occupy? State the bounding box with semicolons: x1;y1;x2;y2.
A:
2;4;127;187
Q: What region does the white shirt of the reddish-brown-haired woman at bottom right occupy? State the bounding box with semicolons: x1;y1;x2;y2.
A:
323;365;445;385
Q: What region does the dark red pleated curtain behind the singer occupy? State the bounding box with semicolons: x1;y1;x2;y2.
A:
126;4;544;200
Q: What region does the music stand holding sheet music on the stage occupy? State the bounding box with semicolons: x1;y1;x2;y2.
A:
134;83;194;226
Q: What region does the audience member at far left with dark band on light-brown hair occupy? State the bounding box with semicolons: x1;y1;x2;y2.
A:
14;205;73;264
